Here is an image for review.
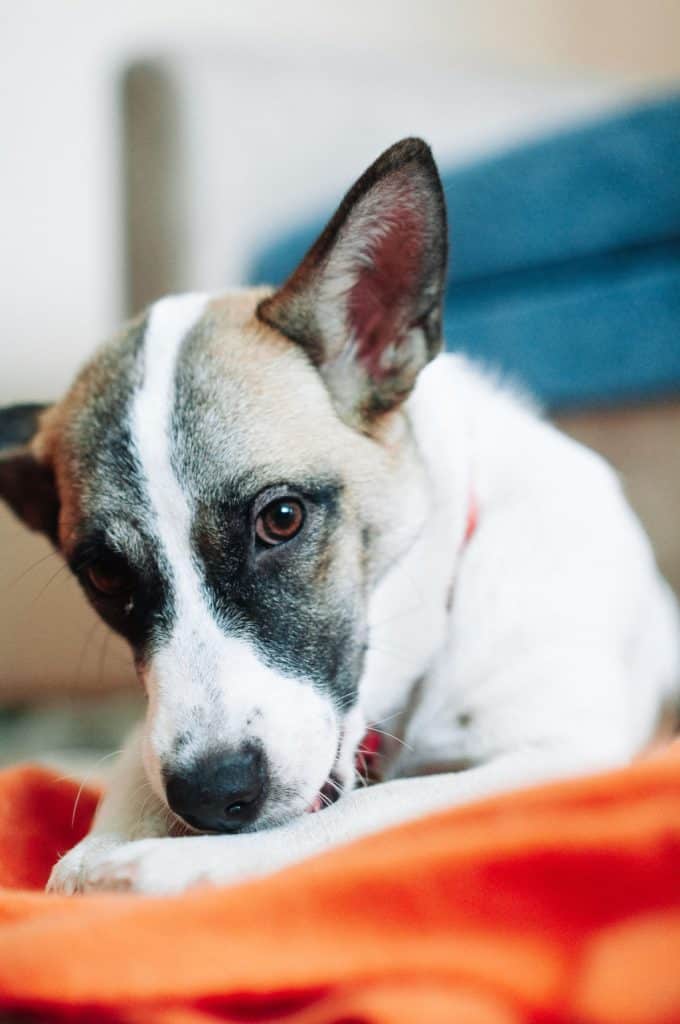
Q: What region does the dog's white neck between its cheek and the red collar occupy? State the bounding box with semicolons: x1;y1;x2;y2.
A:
360;358;474;732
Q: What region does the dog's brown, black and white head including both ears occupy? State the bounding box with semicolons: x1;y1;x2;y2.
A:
0;139;447;831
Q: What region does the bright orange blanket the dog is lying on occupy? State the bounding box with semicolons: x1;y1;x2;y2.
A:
0;744;680;1024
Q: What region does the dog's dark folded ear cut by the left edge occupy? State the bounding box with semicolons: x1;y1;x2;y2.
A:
0;404;58;543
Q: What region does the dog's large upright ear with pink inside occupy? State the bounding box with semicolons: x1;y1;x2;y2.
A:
258;138;448;425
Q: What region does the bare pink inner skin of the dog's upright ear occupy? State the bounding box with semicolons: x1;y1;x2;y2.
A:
348;197;425;379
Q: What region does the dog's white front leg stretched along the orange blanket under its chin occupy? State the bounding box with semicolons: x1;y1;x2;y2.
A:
75;750;610;893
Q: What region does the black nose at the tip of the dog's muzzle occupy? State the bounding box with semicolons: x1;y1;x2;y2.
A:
165;749;266;833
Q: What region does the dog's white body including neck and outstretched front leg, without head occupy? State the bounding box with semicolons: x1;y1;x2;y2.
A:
45;348;680;891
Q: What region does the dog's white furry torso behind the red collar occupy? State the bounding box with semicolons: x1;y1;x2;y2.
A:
391;356;680;774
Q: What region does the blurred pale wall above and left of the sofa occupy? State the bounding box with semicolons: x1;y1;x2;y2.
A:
0;0;680;403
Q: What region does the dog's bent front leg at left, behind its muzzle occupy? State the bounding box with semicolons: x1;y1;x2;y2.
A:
47;729;169;893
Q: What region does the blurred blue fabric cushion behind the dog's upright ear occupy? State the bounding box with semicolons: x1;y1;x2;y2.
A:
250;97;680;408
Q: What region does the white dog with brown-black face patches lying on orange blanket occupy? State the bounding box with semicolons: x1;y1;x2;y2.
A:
0;139;680;893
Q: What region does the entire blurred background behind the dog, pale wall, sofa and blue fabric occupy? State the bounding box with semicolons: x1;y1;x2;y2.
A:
0;0;680;771
